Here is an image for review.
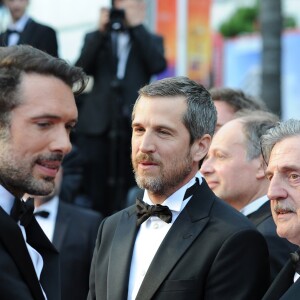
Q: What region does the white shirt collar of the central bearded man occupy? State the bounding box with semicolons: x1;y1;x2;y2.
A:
143;172;202;212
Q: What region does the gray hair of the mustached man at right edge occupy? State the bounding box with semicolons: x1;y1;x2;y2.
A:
261;119;300;163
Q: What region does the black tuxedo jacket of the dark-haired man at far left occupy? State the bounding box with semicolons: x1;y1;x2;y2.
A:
0;207;60;300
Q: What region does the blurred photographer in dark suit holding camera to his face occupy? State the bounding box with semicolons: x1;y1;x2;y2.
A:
75;0;166;216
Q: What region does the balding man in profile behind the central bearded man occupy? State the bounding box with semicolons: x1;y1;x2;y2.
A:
200;111;296;280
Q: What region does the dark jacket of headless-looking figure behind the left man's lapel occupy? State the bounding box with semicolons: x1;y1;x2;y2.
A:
53;202;102;300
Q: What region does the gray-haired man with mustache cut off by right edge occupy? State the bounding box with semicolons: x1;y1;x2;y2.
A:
261;119;300;300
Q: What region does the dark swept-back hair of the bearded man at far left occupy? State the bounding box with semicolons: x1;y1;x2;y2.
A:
0;45;88;126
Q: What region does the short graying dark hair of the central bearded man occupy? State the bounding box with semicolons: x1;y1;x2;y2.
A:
132;77;217;143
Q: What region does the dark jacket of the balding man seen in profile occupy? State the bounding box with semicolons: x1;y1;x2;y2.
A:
248;201;298;280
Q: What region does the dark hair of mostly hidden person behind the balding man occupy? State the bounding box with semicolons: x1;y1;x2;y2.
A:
209;87;267;112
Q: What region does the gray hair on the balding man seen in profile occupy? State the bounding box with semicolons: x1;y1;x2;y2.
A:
237;111;279;160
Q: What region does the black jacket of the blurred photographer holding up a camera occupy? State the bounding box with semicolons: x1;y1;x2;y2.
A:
76;25;166;135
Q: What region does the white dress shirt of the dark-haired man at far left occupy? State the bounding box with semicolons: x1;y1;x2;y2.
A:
0;185;47;300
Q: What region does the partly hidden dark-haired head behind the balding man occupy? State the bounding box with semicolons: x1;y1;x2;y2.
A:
209;87;267;130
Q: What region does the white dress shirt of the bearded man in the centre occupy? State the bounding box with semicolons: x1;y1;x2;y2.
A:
128;172;202;300
